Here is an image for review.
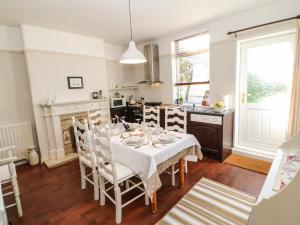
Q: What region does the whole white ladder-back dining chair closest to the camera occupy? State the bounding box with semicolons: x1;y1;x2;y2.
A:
92;127;149;223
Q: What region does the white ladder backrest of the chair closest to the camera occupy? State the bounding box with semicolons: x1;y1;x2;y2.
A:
91;126;118;185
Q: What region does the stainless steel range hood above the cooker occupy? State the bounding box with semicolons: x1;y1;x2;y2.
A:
139;43;162;84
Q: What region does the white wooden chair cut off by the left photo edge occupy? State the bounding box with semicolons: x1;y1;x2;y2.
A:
0;146;23;217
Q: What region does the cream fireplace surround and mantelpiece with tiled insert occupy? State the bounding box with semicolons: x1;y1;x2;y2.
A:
42;98;109;161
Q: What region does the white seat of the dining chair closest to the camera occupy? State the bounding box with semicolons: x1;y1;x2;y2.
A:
98;162;136;184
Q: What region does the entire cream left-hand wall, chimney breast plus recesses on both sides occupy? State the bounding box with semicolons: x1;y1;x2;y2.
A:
0;25;134;159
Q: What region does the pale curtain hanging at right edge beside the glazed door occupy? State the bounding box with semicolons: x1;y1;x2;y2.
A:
287;20;300;138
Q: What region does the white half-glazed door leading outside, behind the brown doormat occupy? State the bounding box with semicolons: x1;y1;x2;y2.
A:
236;34;294;154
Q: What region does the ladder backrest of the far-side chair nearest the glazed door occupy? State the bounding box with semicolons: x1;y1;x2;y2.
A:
165;107;187;133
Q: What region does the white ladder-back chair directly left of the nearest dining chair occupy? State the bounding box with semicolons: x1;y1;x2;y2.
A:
72;117;99;200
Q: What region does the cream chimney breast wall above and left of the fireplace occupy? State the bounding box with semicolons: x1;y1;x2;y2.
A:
21;25;108;160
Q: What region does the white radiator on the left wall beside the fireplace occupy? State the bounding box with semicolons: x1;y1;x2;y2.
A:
0;122;34;160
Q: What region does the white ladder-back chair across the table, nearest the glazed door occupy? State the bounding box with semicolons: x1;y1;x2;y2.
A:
165;107;189;186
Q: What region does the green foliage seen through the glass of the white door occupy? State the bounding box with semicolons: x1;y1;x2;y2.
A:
247;74;288;103
